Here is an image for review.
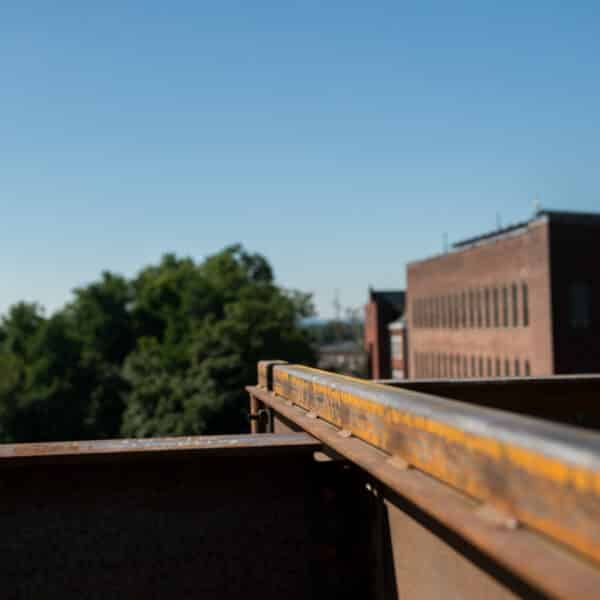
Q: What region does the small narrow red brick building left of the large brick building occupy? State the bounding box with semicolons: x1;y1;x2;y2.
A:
365;288;405;379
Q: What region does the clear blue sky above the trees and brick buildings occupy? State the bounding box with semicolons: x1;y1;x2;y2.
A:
0;0;600;316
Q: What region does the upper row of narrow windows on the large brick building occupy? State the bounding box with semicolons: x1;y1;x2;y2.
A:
412;283;529;329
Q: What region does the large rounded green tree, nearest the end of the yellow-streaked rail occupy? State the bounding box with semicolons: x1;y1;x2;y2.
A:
122;246;314;436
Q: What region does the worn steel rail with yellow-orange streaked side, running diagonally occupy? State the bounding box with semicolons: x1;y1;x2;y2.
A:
253;365;600;561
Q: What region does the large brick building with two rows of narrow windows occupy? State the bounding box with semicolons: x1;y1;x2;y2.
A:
407;211;600;378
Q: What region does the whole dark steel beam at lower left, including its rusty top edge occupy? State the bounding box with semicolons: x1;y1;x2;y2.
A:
0;434;372;600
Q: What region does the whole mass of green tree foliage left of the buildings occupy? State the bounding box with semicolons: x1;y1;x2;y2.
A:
0;246;314;442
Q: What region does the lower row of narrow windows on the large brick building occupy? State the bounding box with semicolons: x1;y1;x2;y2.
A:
413;352;531;378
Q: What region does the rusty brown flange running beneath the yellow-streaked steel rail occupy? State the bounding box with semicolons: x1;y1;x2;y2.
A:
249;387;600;599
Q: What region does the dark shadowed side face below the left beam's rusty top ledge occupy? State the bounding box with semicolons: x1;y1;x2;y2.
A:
0;448;322;600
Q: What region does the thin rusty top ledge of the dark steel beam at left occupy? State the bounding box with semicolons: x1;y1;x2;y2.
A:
0;433;321;468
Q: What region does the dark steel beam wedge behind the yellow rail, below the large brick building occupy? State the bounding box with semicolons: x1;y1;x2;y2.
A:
375;375;600;429
